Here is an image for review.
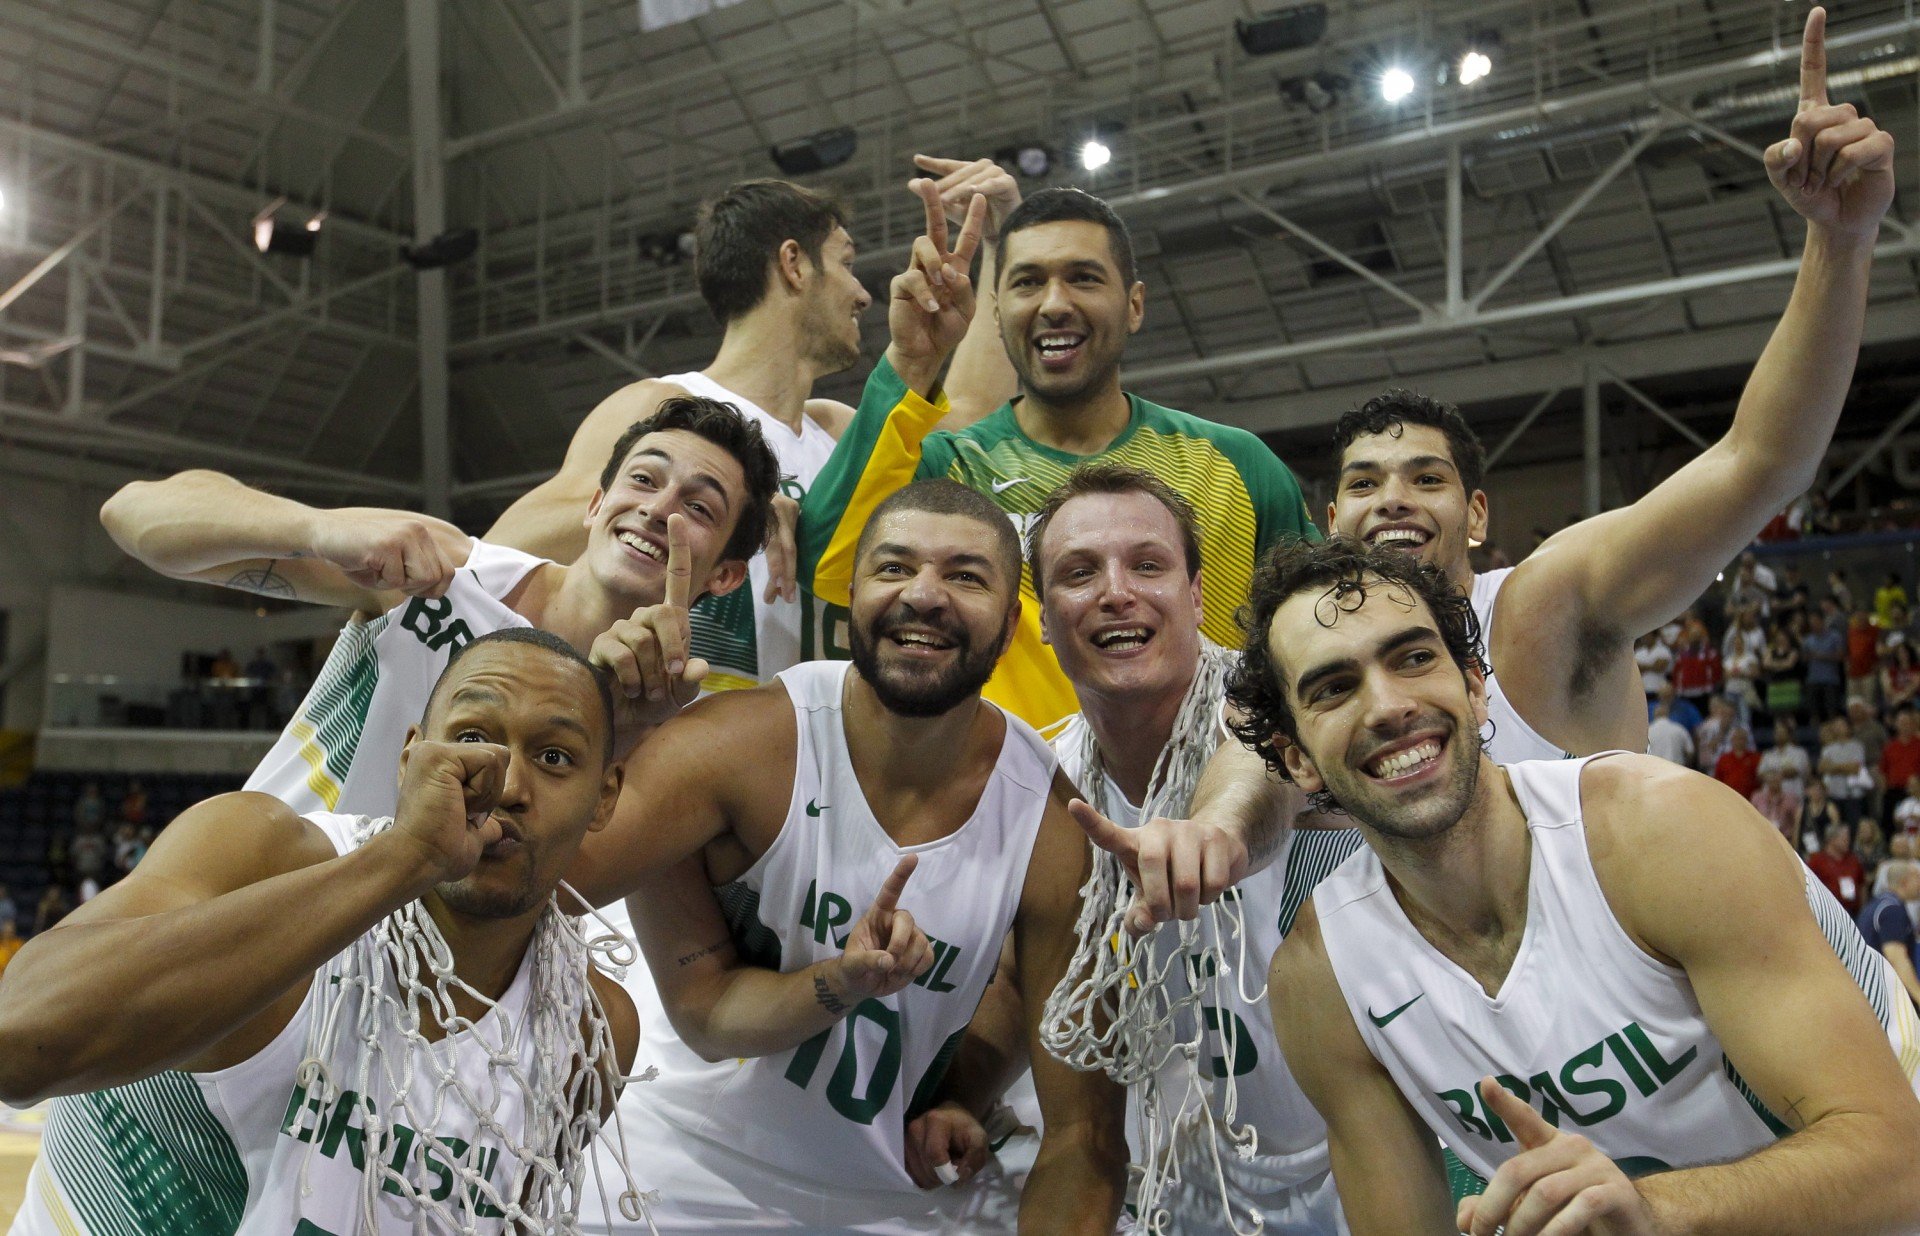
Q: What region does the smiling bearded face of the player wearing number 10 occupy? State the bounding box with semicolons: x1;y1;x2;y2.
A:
849;511;1020;716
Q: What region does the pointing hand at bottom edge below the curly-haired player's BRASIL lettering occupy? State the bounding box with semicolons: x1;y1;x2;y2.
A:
1453;1077;1655;1236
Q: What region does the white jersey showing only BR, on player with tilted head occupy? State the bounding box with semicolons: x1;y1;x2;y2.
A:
246;539;545;818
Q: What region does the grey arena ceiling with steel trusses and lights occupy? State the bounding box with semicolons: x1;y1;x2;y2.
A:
0;0;1920;518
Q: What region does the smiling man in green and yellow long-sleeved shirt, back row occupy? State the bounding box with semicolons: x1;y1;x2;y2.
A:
801;188;1317;725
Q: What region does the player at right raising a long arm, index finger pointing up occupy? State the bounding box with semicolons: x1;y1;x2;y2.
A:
1075;8;1893;921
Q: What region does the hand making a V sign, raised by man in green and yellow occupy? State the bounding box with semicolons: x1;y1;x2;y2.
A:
887;180;987;393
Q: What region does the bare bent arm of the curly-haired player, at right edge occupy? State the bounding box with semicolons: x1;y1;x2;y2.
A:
1582;756;1920;1236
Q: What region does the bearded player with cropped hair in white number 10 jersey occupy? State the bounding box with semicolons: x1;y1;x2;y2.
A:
574;477;1127;1234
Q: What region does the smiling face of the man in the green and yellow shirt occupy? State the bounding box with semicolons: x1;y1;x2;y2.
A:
995;219;1146;403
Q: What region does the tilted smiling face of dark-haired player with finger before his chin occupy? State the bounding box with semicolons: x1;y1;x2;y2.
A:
580;430;749;608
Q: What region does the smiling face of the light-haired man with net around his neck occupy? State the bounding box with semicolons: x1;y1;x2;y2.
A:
1039;493;1200;697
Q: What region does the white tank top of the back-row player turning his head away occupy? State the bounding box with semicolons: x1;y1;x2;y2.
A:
660;372;833;691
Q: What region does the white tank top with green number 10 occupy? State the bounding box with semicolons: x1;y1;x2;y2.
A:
634;662;1054;1192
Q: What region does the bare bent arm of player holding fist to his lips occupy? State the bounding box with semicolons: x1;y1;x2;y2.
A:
0;793;432;1105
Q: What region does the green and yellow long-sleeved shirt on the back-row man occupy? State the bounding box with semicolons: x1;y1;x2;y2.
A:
801;359;1319;725
